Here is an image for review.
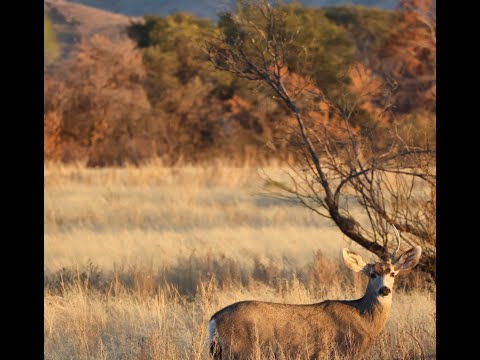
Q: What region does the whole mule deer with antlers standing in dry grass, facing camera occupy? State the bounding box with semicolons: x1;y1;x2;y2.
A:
208;229;422;360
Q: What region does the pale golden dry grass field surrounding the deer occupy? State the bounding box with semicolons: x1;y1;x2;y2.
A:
44;163;436;360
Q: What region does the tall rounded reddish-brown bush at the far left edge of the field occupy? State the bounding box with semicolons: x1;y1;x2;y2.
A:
44;36;152;166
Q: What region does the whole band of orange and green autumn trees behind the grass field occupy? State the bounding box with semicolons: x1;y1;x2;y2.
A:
44;0;436;166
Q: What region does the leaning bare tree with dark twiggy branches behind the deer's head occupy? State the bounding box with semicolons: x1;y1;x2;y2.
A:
207;0;436;278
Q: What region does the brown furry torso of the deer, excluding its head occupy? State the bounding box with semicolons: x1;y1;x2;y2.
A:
212;297;390;360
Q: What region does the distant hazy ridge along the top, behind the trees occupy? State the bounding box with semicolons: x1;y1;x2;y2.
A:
44;0;399;59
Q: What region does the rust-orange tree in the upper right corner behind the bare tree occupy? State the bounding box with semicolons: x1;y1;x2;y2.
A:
326;0;436;114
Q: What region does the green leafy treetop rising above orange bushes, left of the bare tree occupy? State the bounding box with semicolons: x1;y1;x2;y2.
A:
128;13;233;103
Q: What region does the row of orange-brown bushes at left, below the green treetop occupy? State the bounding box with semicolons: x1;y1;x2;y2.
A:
44;35;292;166
